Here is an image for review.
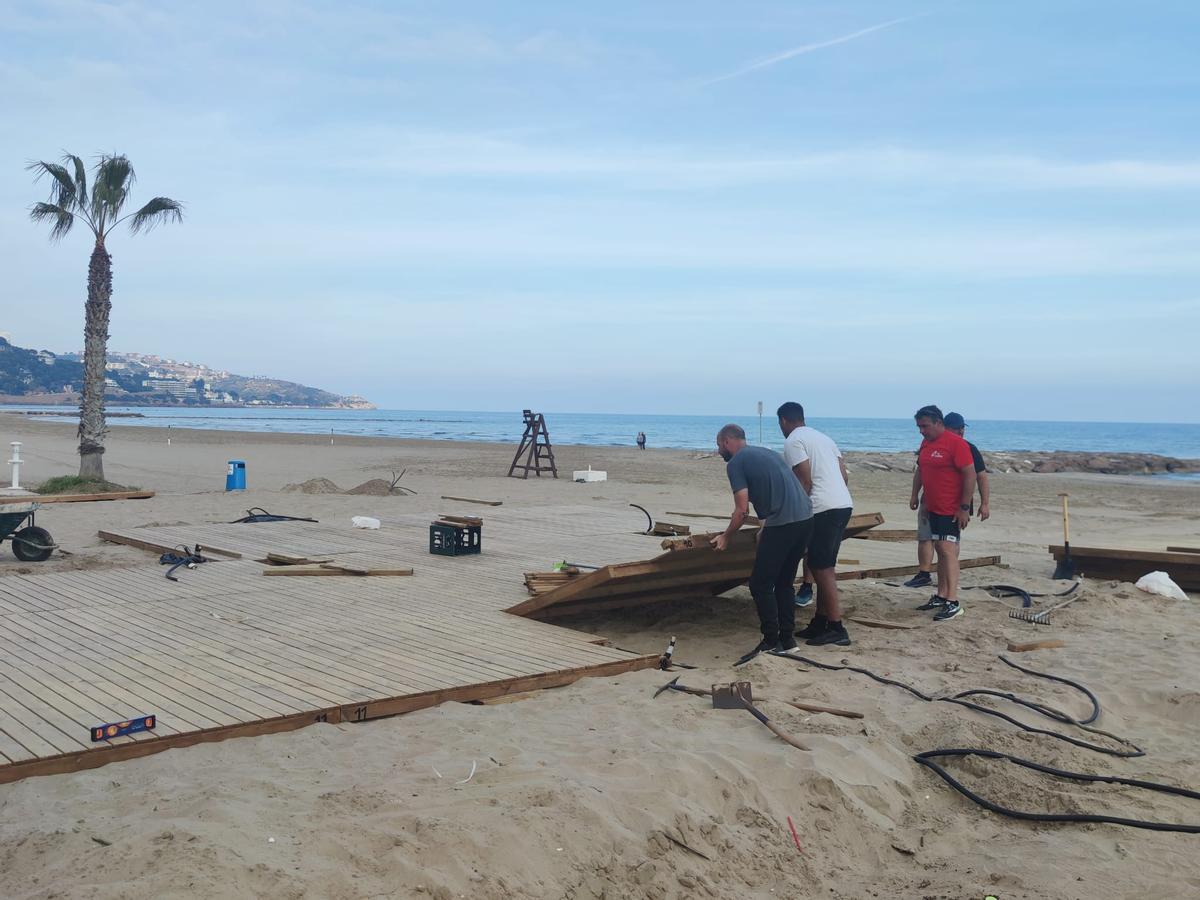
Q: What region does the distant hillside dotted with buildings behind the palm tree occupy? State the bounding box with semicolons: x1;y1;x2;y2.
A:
0;337;374;409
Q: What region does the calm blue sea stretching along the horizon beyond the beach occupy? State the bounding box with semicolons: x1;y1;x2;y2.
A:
6;407;1200;458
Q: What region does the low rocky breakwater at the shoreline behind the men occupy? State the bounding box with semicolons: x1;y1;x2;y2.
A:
846;448;1200;475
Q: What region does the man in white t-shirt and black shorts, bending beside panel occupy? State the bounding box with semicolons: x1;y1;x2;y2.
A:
775;402;854;647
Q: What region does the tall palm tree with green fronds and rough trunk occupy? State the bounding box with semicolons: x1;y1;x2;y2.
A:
26;154;184;481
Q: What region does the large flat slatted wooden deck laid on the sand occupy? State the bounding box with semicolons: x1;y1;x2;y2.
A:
0;504;658;782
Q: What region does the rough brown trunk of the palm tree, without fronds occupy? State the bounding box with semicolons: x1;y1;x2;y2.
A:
79;238;113;481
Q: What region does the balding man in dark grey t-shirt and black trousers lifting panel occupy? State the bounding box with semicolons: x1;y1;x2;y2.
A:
712;425;812;664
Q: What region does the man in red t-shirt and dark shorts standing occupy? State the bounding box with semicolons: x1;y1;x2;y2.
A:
908;406;976;622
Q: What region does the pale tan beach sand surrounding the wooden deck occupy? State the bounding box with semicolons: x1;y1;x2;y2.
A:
0;415;1200;900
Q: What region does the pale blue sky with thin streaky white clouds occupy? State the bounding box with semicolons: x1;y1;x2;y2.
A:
0;0;1200;422
